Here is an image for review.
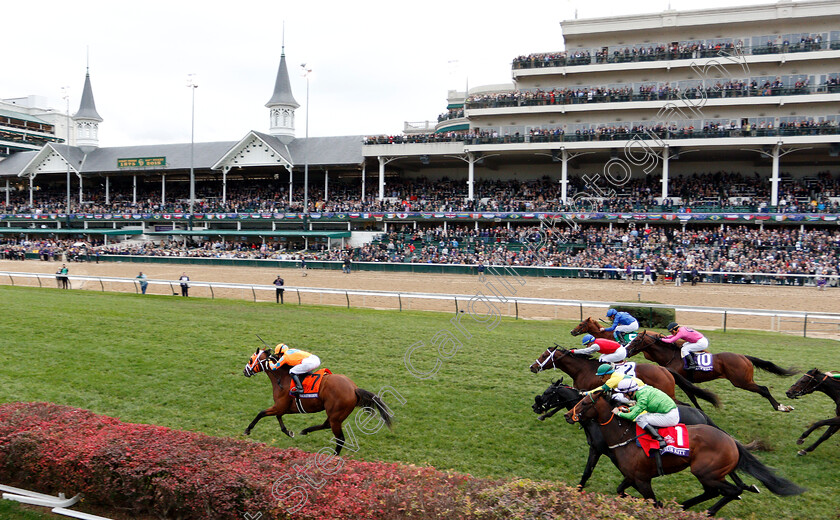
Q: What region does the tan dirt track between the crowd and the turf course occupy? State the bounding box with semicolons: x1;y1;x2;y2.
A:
0;260;840;338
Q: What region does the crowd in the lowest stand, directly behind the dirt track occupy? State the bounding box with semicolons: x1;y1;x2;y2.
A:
0;222;840;284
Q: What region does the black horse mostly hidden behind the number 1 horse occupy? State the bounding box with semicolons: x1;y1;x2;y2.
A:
531;378;719;495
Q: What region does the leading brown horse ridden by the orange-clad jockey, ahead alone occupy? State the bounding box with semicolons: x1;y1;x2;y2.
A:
243;349;391;455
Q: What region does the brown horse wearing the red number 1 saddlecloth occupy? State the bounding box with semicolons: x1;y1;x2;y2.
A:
564;393;805;516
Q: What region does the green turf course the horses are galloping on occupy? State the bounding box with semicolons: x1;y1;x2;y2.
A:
0;286;840;519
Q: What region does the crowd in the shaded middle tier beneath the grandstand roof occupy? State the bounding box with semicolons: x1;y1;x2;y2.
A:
0;171;840;214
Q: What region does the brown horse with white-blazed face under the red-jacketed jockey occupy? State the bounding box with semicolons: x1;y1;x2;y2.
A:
530;347;720;408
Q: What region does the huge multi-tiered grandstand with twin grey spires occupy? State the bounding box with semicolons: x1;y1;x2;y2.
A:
0;0;840;284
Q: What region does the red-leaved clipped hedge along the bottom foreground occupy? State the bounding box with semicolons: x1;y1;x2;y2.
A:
0;403;705;520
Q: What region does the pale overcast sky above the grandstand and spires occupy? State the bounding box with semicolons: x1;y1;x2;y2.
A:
0;0;780;146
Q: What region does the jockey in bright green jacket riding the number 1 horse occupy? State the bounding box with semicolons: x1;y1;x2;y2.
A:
613;378;680;449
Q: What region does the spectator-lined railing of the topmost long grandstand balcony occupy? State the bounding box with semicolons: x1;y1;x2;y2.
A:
511;40;840;70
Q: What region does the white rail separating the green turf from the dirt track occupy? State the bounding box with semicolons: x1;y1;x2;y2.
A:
0;271;840;337
